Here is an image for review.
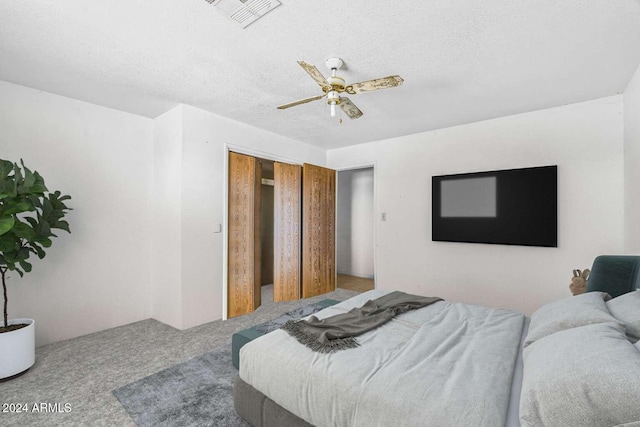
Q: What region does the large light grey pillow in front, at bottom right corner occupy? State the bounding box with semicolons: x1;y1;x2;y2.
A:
520;323;640;427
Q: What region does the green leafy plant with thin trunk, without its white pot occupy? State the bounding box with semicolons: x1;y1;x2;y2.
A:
0;159;71;331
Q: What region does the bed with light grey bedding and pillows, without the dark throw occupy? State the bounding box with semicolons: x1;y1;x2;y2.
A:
234;290;640;427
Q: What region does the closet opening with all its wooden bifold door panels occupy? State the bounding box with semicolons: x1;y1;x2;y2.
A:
227;151;336;318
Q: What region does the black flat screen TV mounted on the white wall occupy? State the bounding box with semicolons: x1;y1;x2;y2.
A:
431;166;558;248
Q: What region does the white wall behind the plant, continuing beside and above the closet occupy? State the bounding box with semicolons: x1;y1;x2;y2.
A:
0;81;326;345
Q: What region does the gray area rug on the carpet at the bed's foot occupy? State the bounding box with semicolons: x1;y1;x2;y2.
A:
113;304;336;427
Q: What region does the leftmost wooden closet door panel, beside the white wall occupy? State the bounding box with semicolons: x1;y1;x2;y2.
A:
227;152;262;317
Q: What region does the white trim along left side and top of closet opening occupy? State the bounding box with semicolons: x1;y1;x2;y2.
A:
222;142;304;320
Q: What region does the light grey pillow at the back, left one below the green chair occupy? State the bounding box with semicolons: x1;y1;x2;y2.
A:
524;292;617;347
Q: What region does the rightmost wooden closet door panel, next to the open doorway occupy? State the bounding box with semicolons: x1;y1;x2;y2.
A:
302;163;336;298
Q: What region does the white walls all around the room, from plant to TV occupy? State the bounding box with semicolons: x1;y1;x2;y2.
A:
0;73;640;345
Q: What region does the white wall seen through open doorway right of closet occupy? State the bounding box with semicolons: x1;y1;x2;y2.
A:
336;168;374;278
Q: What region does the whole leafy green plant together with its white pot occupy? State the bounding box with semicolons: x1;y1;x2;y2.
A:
0;159;71;380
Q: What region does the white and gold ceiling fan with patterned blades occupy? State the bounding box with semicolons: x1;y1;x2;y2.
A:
278;58;404;119
